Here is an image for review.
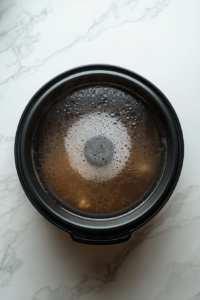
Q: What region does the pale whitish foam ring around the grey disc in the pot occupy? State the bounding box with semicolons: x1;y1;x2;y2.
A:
65;113;131;181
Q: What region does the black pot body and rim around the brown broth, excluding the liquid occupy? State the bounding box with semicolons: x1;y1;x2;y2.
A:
15;65;184;244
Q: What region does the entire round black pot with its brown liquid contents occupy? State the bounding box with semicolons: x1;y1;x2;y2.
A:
15;65;184;244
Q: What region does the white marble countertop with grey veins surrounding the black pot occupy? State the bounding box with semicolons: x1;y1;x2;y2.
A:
0;0;200;300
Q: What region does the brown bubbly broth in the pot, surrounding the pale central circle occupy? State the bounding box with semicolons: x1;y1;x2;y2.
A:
34;86;165;214
